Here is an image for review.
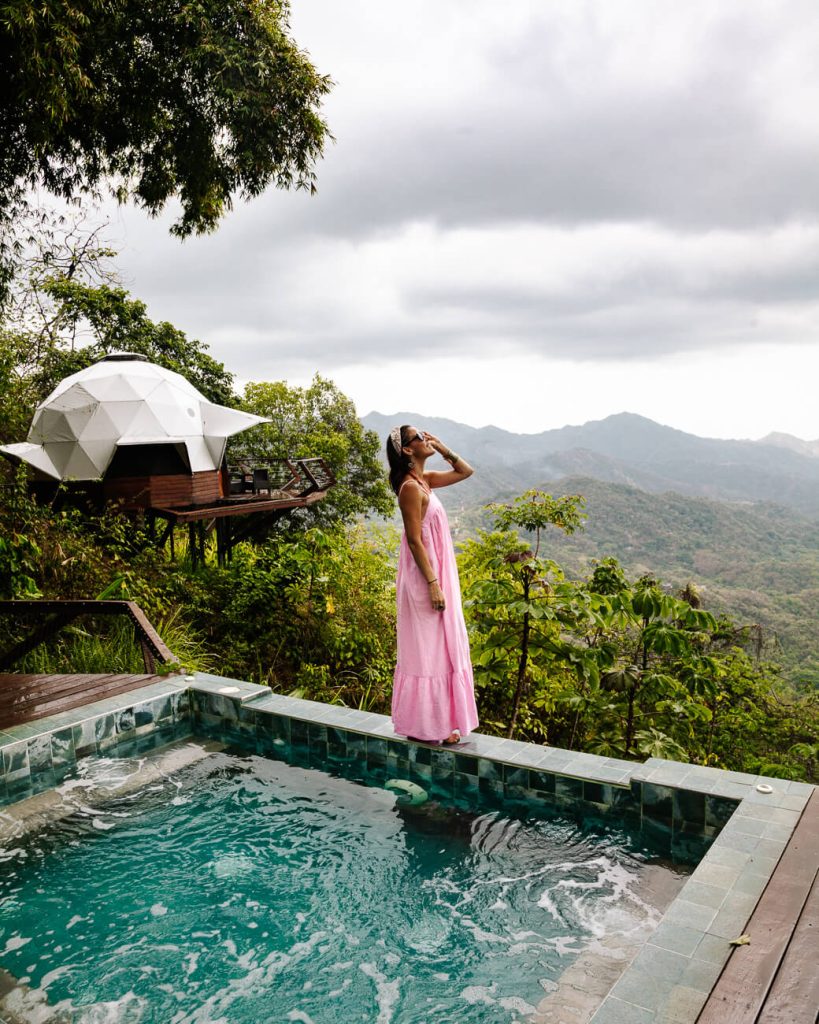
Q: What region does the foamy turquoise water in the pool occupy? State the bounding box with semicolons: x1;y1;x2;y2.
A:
0;753;683;1024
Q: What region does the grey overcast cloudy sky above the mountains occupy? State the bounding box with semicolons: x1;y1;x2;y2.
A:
111;0;819;439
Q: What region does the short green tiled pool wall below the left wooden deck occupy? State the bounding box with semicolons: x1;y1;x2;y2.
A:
0;684;190;806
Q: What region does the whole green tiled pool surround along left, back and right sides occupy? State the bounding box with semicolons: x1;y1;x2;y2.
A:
0;673;813;1024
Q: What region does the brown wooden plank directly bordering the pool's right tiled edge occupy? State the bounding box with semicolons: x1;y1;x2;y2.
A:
697;791;819;1024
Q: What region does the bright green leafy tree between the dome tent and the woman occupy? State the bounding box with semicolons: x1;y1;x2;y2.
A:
236;374;395;526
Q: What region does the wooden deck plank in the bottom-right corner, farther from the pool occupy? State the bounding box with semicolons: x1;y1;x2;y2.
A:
759;873;819;1024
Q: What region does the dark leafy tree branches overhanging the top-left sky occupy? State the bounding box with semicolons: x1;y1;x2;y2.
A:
0;0;331;262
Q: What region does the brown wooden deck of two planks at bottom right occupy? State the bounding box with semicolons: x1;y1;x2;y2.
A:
697;790;819;1024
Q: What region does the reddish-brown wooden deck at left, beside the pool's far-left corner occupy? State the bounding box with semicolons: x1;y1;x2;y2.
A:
0;674;167;729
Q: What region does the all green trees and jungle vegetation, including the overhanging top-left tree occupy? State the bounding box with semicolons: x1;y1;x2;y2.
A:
0;9;819;780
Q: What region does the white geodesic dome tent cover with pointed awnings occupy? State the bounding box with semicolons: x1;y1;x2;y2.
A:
0;352;265;480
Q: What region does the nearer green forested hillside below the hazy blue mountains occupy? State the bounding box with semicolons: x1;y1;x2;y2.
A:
459;477;819;686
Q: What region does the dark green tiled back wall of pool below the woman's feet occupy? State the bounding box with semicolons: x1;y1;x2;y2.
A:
191;690;738;864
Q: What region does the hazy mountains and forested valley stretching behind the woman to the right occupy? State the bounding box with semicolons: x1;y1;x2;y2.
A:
362;413;819;686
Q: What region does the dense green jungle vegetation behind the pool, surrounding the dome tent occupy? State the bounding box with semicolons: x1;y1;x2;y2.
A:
0;260;819;780
